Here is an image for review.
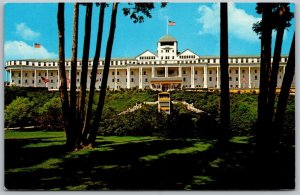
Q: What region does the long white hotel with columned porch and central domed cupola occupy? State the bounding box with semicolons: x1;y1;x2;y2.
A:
5;35;287;90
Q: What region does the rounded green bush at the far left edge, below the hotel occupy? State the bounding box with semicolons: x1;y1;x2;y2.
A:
4;97;33;127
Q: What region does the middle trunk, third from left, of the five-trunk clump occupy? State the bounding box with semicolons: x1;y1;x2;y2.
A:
77;3;93;130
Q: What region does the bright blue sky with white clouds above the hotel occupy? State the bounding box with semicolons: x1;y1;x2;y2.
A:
4;3;295;80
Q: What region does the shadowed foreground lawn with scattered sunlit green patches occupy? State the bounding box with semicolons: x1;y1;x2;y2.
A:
5;135;293;190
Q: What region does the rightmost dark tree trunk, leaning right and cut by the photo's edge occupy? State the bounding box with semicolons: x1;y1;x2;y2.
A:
275;33;295;134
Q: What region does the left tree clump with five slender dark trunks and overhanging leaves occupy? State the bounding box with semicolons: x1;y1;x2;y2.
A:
58;3;166;150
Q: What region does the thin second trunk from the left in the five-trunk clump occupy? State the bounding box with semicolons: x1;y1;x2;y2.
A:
70;3;80;143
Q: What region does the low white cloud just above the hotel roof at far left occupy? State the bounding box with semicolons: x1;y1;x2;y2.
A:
4;41;57;60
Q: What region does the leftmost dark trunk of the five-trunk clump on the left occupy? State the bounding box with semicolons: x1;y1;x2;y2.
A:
57;3;75;150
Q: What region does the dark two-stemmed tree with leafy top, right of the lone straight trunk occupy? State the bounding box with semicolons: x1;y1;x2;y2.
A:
253;3;294;150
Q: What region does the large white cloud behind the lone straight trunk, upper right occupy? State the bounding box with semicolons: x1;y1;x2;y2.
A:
197;3;260;41
